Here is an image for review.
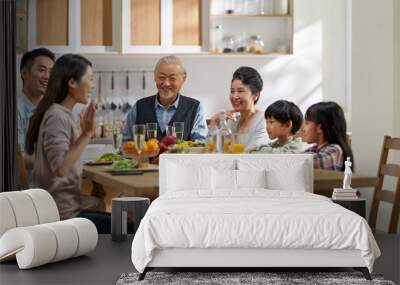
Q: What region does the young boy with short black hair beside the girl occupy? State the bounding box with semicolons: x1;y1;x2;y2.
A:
251;100;308;153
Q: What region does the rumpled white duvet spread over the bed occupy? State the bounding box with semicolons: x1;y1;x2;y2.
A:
132;189;380;272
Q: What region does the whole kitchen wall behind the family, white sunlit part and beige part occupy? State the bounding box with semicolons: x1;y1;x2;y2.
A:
17;0;400;229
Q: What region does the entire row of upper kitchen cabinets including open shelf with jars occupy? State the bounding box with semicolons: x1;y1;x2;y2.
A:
28;0;293;56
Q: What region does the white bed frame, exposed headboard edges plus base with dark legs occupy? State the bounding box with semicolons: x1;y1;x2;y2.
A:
139;154;371;280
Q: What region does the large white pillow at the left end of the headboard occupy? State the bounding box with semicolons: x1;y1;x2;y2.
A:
167;163;212;191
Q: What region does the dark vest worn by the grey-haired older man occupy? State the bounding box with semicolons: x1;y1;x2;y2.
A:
135;95;200;140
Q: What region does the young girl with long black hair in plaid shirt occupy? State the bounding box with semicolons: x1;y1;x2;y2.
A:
303;102;354;171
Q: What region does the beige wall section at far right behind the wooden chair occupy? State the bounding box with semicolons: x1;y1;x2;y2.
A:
352;0;400;230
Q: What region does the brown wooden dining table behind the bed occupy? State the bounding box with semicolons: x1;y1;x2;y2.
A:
82;165;378;201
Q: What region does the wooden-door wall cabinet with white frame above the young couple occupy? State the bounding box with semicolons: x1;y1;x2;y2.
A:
28;0;121;53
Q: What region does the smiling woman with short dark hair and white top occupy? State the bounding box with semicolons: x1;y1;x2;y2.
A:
210;66;268;150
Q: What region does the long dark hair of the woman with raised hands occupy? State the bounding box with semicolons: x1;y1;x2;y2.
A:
26;54;92;154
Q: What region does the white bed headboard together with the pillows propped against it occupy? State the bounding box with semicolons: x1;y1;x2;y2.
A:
159;154;313;195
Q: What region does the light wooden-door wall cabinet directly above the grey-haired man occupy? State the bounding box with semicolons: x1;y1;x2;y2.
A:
122;0;203;54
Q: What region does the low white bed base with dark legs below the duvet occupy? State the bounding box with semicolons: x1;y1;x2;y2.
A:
139;248;371;281
